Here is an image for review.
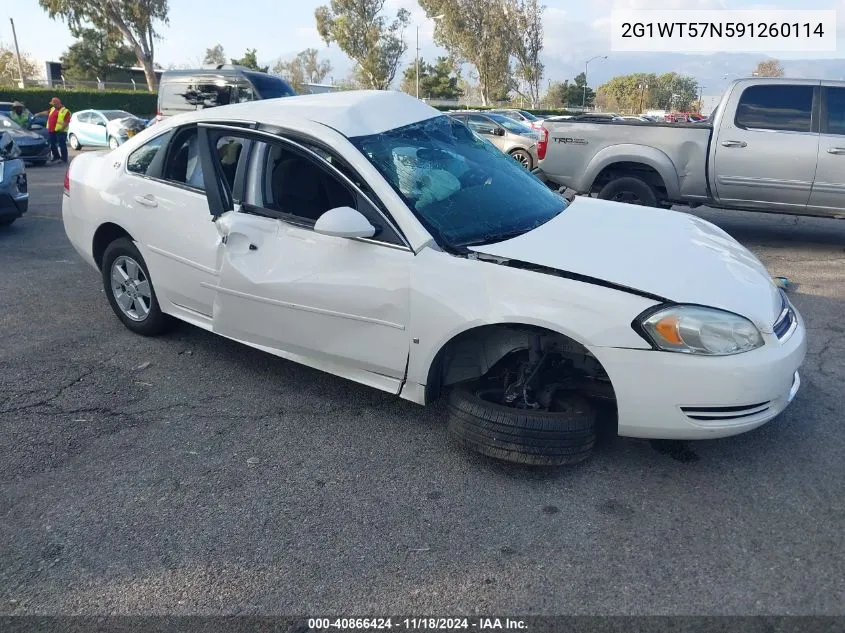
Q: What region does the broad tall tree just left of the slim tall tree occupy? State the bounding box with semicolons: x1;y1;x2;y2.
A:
419;0;514;105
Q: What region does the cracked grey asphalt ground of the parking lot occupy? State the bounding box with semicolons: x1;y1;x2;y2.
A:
0;157;845;615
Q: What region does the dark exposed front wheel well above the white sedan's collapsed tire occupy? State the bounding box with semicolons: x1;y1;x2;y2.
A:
425;324;615;402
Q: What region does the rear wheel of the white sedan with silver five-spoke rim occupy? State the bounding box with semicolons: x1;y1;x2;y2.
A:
102;237;172;336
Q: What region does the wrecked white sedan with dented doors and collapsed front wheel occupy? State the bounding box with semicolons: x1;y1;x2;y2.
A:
63;91;806;464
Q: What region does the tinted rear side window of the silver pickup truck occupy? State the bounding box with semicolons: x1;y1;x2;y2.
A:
735;85;813;132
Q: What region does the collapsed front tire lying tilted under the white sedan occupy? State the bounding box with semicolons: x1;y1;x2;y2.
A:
447;384;596;466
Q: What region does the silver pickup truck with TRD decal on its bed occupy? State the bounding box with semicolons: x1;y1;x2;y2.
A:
538;78;845;218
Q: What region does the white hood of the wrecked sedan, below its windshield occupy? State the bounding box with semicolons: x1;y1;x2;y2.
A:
471;198;782;332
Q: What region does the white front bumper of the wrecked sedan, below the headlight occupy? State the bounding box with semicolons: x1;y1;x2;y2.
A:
594;311;807;440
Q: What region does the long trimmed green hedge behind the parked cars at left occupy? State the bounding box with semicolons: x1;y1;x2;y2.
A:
0;86;158;117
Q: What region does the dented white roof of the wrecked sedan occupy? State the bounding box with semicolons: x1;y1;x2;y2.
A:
166;90;445;137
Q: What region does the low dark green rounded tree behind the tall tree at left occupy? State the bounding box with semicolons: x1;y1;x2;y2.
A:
59;29;136;81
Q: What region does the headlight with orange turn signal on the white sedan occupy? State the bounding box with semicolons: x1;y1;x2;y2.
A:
635;305;763;356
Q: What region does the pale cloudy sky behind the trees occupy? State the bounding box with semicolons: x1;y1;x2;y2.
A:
0;0;845;95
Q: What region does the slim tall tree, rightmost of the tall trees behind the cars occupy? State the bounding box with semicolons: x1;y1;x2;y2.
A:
508;0;545;108
